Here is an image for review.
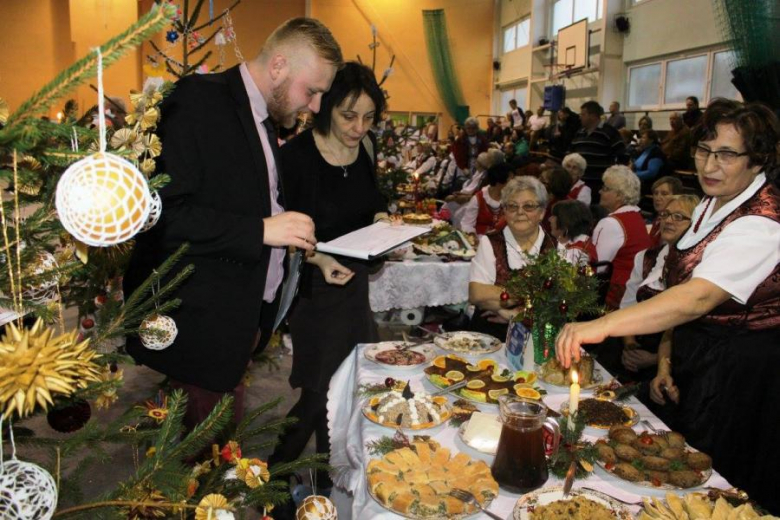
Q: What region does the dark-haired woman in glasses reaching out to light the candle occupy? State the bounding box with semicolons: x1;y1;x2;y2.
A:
556;99;780;514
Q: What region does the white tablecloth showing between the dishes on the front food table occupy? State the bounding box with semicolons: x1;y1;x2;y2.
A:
328;345;731;520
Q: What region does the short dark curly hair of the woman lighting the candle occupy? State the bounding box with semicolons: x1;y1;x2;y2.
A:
693;98;780;179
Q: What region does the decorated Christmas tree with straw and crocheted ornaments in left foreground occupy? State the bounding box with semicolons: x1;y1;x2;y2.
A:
0;2;324;519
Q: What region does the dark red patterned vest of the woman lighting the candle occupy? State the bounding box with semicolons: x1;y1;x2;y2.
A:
666;183;780;330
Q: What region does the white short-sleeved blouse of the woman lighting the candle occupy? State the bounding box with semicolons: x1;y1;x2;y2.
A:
677;173;780;304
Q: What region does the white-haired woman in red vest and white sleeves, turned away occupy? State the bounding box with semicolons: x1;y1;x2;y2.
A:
593;166;650;310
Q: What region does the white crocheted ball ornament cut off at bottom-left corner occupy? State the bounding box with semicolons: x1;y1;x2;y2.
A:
0;459;57;520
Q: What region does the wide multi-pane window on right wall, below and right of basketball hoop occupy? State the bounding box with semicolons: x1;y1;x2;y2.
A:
628;49;742;108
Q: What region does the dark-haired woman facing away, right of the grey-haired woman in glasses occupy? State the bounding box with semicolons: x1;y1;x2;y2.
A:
550;200;598;265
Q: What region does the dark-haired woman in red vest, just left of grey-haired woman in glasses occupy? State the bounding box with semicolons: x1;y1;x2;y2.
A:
460;163;512;236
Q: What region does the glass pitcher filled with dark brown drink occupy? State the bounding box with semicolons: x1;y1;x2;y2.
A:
490;395;561;494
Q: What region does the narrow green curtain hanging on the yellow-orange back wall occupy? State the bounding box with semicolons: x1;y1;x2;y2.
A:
423;9;469;123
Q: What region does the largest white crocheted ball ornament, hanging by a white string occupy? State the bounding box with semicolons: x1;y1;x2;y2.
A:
56;152;152;247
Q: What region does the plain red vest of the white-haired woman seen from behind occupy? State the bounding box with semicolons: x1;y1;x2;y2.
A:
606;211;650;309
